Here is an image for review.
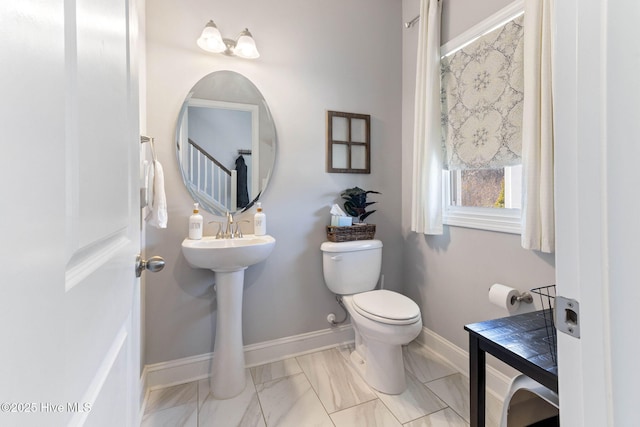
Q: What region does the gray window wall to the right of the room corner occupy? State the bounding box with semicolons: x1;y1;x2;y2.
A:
402;0;555;349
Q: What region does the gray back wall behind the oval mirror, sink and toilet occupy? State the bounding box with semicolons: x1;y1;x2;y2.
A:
145;0;404;364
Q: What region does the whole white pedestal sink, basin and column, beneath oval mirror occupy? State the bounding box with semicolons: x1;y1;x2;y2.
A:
182;235;276;399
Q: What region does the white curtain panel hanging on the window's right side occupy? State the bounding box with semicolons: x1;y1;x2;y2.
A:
521;0;555;253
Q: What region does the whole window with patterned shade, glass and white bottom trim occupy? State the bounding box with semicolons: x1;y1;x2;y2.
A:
441;2;523;234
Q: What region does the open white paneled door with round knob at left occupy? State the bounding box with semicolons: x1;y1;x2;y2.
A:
0;0;140;426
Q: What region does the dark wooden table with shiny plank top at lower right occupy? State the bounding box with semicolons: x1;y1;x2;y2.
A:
464;310;558;427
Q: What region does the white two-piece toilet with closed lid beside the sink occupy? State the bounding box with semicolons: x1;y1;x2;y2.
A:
320;240;422;394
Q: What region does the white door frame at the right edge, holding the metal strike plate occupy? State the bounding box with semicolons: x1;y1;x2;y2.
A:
555;0;640;427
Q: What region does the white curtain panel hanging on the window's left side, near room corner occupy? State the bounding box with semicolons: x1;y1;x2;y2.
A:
411;0;443;234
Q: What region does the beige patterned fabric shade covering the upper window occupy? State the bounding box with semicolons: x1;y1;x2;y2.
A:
441;15;524;170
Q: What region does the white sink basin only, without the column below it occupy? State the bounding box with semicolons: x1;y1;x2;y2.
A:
182;234;276;272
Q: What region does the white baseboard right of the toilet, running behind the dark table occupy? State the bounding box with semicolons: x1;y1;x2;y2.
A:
417;326;511;401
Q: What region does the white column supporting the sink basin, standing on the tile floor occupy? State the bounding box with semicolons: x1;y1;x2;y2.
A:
210;268;245;399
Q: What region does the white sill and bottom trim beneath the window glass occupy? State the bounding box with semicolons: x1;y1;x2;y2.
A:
443;206;521;234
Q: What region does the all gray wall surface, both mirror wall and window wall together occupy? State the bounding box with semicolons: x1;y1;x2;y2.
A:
145;0;555;370
